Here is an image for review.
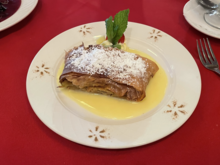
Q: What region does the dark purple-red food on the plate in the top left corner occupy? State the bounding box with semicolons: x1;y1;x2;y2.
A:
0;0;21;22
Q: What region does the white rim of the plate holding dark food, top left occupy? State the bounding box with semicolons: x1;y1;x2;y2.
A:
0;0;38;31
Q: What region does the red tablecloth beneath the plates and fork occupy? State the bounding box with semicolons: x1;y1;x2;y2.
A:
0;0;220;165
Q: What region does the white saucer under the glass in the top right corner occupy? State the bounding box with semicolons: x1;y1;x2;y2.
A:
183;0;220;39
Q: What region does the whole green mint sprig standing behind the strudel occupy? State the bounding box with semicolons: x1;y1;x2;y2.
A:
105;9;129;48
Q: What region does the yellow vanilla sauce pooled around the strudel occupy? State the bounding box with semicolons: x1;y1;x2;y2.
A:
56;49;168;120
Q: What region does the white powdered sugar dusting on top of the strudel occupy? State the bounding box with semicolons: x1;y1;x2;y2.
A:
66;45;148;79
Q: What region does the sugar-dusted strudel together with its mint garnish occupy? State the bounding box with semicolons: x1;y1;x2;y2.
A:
59;9;159;101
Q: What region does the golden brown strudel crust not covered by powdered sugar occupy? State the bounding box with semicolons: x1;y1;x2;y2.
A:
59;45;159;101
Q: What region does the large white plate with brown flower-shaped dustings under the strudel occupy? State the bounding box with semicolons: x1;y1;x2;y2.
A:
26;22;201;149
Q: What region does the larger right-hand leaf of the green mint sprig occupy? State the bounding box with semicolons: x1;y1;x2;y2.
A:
112;9;129;45
